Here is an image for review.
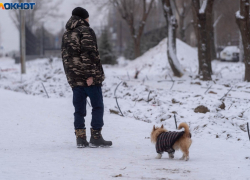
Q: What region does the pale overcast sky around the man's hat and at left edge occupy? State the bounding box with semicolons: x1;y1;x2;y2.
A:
0;0;105;52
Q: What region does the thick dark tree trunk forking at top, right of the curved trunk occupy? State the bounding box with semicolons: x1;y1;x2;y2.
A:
192;0;214;80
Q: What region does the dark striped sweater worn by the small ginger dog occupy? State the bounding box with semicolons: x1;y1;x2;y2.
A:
155;131;184;154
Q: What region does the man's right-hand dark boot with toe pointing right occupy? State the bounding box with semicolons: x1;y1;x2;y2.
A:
89;128;112;148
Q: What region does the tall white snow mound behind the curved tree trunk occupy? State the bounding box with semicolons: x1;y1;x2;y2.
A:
126;38;198;77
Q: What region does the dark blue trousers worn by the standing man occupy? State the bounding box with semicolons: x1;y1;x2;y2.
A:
72;86;104;130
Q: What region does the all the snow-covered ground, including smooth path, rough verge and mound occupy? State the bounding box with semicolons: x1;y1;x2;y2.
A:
0;39;250;180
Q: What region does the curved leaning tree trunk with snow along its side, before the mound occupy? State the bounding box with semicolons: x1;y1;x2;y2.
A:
162;0;183;77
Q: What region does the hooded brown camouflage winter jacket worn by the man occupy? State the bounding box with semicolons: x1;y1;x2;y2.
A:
61;16;105;88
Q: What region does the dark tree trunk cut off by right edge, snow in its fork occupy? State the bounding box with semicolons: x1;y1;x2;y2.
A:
236;0;250;82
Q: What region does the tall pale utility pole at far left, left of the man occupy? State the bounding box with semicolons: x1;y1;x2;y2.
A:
19;0;26;74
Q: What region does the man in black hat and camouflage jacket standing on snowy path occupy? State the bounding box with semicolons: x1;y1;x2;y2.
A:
62;7;112;147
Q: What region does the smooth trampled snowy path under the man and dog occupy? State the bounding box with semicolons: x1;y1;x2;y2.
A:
0;90;250;180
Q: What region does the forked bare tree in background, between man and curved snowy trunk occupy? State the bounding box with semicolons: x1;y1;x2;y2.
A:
110;0;154;58
